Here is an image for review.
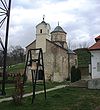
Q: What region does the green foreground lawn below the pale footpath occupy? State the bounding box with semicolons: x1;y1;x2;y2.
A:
0;87;100;110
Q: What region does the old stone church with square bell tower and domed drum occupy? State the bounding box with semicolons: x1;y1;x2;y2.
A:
26;18;76;82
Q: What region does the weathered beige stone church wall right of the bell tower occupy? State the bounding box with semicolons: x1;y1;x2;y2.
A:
45;40;68;81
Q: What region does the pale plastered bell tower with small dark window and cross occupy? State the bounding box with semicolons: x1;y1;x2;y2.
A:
36;16;50;53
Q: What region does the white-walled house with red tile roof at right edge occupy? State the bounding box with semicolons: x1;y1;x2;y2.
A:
89;35;100;79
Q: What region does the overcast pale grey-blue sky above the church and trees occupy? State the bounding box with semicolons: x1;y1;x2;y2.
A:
0;0;100;48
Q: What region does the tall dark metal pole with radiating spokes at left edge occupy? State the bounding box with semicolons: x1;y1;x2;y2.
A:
0;0;11;95
